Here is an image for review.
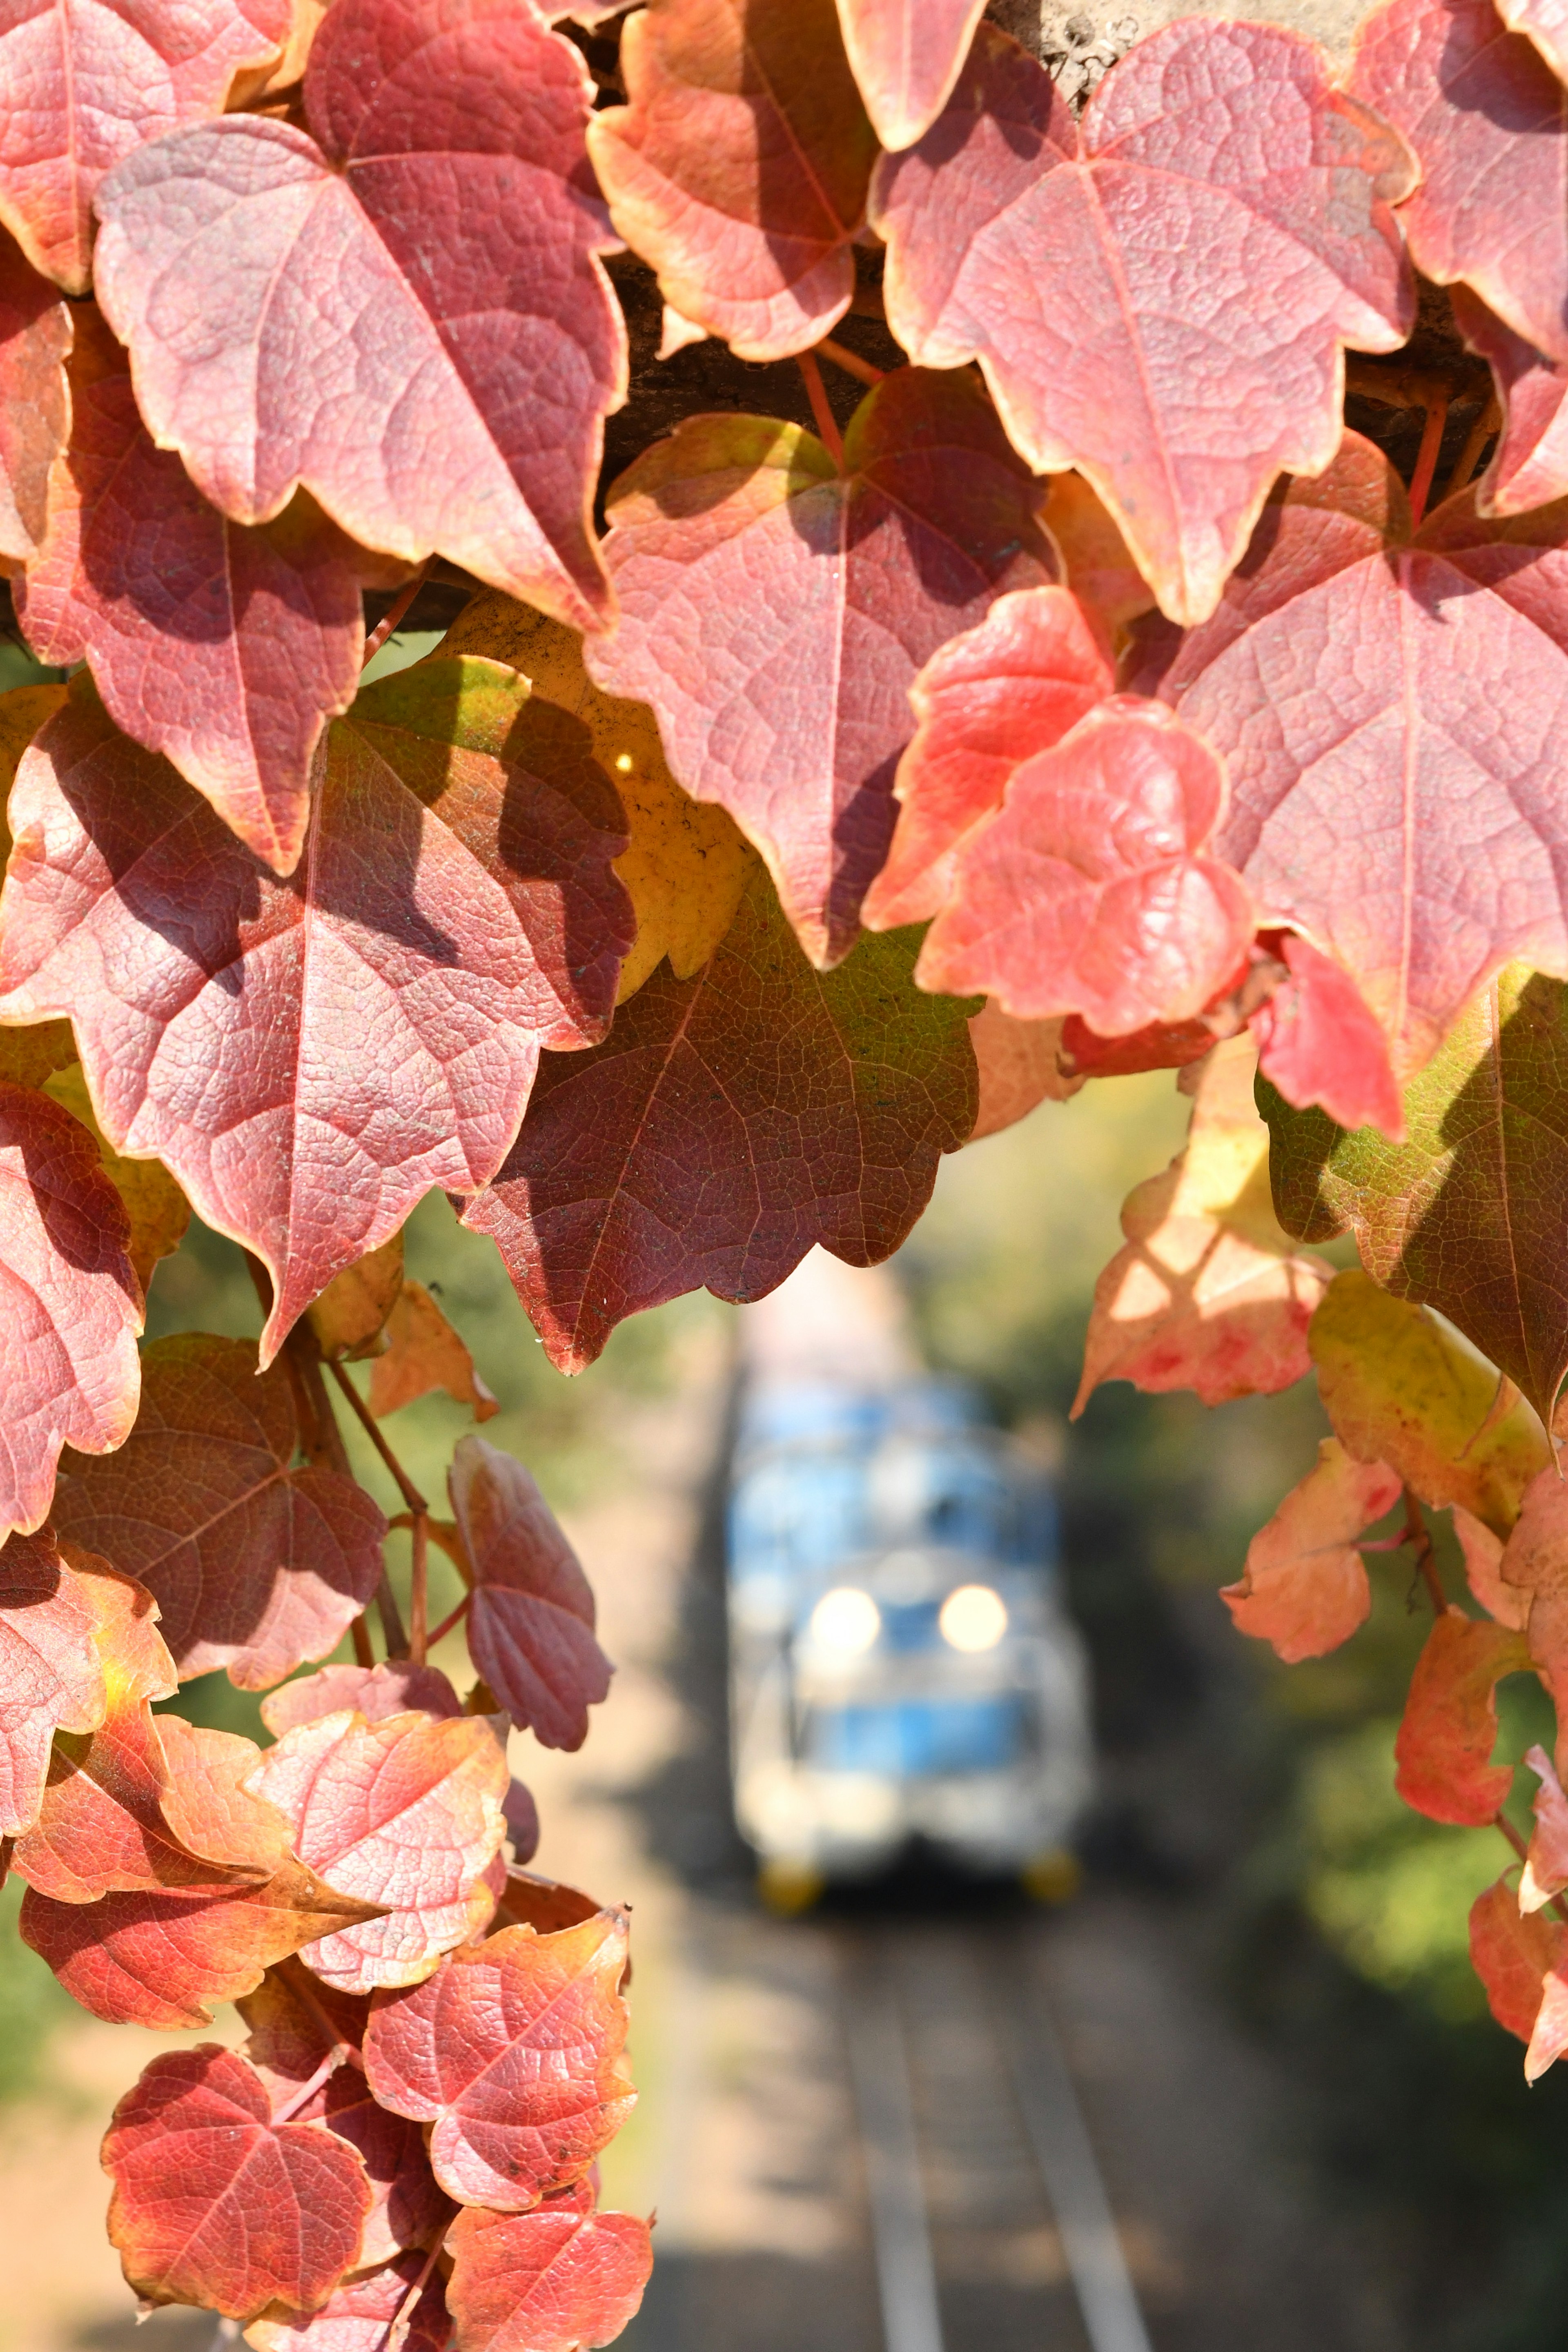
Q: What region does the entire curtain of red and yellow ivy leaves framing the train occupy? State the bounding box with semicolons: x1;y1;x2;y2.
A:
15;0;1568;2323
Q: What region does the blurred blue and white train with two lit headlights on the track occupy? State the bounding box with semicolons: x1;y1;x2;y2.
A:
729;1378;1093;1907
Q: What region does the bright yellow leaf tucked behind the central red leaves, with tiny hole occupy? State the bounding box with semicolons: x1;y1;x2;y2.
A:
440;590;755;1004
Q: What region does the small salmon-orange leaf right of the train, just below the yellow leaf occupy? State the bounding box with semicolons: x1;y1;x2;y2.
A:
1220;1437;1401;1665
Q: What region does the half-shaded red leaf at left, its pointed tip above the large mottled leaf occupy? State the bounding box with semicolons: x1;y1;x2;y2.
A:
16;306;392;873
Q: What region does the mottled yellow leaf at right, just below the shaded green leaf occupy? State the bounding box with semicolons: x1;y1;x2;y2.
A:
1307;1268;1552;1536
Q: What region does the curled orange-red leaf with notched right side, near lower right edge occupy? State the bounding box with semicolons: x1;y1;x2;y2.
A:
1394;1609;1530;1830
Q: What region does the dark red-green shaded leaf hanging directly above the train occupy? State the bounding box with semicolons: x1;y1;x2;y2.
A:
463;875;976;1371
